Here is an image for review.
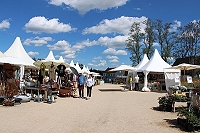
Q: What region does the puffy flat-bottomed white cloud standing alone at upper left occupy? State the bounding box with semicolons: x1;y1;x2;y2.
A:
25;16;75;34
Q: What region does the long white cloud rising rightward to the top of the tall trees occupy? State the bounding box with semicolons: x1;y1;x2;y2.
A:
83;16;147;35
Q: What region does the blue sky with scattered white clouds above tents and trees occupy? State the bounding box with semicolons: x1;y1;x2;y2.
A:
0;0;200;70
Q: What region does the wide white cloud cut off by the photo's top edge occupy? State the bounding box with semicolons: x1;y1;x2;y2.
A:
49;0;129;14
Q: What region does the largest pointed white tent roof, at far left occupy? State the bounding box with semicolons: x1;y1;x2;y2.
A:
4;37;35;64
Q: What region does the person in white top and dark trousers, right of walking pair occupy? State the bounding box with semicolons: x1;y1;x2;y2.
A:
86;74;94;100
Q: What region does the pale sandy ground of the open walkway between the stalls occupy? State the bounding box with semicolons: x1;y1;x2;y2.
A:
0;84;188;133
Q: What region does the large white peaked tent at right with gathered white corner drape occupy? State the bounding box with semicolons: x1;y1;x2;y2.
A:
139;49;180;91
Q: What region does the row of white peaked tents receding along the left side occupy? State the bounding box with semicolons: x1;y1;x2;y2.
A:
0;37;99;79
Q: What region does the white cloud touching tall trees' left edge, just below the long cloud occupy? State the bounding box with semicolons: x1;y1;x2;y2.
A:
98;36;128;48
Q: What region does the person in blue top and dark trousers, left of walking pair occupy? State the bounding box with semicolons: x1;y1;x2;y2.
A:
78;72;86;98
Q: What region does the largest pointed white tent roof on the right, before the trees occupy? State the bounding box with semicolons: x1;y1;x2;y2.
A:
140;49;171;72
